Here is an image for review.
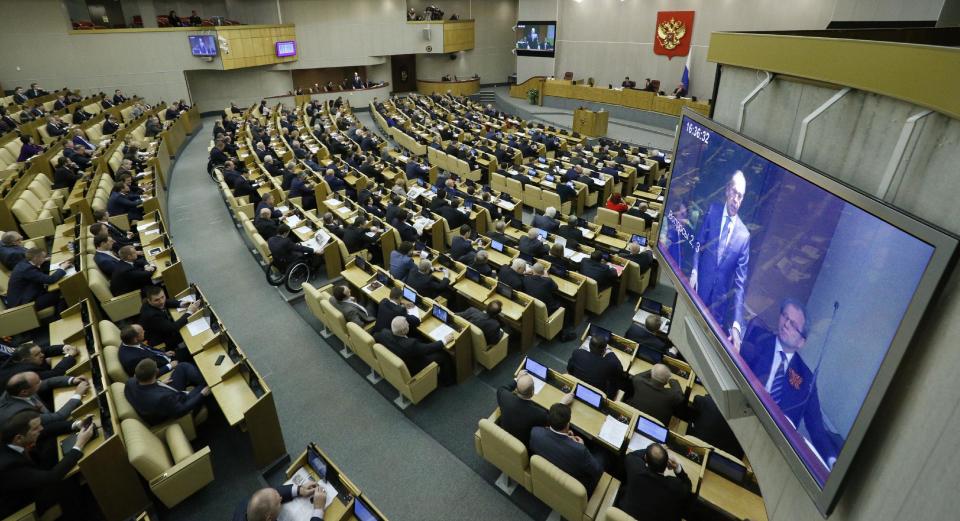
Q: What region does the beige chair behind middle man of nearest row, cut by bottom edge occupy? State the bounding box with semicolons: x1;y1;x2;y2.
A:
530;455;611;521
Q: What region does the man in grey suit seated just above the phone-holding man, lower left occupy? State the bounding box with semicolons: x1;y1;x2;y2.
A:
0;371;90;437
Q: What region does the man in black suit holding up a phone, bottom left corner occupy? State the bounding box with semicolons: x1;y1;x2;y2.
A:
0;410;94;521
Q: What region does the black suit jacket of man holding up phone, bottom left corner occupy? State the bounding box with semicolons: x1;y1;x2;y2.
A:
0;445;83;517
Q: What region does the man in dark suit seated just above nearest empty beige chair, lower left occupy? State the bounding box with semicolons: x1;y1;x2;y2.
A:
123;358;210;426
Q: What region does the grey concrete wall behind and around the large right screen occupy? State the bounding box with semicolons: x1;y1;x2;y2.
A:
696;63;960;521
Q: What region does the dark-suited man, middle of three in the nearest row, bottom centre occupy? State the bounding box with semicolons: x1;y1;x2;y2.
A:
530;403;603;497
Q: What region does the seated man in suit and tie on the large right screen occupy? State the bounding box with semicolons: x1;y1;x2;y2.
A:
740;298;837;467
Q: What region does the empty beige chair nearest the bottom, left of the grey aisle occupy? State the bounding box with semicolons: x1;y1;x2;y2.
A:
120;418;213;508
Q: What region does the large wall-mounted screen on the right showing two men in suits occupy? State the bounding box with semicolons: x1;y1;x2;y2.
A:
657;109;957;515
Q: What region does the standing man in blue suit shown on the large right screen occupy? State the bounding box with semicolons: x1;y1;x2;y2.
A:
690;170;750;350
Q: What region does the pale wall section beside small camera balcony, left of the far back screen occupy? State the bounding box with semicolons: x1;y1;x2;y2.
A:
410;0;517;83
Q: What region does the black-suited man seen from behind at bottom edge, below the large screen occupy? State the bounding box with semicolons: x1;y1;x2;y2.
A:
615;443;693;521
